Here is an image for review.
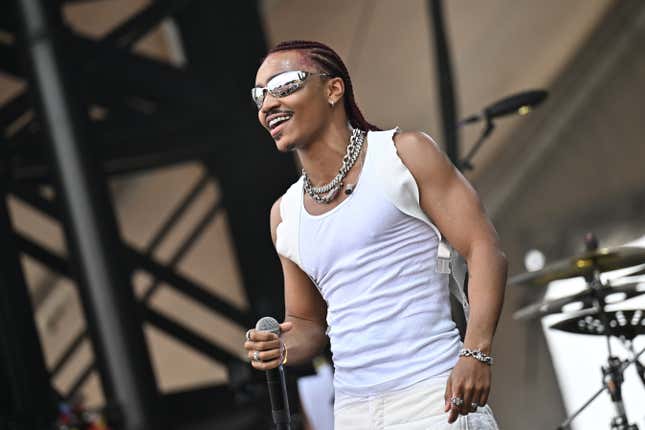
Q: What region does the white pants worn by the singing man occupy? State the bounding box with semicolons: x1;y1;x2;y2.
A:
334;374;499;430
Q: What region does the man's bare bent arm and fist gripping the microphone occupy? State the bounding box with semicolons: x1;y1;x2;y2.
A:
244;199;327;370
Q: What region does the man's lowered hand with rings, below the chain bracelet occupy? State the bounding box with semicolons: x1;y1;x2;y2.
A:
444;357;491;423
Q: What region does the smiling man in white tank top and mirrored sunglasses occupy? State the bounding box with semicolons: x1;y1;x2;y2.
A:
244;41;507;430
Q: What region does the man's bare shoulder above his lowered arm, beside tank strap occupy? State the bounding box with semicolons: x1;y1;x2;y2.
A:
394;131;454;183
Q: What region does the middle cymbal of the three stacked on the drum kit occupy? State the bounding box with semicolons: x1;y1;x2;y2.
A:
513;282;645;320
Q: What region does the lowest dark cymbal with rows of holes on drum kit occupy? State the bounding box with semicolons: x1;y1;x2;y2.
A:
551;309;645;339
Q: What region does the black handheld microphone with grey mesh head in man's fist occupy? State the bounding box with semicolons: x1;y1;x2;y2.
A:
255;317;291;430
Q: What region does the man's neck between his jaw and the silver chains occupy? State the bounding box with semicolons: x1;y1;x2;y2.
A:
297;121;352;186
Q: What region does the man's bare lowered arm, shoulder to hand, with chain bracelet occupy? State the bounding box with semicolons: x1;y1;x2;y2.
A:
395;132;507;420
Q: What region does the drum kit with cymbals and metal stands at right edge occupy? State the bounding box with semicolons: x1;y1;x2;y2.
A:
509;234;645;430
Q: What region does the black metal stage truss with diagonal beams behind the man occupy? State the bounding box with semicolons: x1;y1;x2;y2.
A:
0;0;297;430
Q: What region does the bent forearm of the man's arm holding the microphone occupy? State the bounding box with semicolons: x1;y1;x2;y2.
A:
281;315;328;364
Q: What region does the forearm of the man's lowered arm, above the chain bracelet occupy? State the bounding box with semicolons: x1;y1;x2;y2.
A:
464;243;507;354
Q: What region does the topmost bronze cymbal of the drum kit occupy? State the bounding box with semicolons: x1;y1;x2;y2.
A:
508;246;645;286
